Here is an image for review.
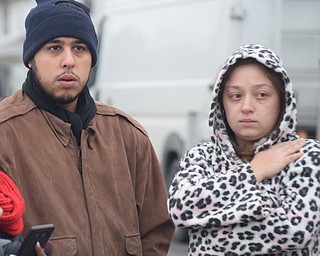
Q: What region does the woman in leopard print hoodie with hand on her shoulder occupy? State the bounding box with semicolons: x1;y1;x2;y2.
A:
168;44;320;255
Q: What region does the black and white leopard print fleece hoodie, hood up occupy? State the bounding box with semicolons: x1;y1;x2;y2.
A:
168;44;320;256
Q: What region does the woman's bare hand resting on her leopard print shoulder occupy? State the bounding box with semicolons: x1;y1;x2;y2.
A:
250;139;305;182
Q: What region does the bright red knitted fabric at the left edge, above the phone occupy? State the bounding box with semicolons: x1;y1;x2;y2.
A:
0;171;25;236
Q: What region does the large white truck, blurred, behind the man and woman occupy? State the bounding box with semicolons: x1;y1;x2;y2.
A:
91;0;320;190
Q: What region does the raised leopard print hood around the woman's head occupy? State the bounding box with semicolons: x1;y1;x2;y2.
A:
209;44;297;158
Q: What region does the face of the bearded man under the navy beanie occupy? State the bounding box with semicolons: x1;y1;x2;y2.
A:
29;37;92;112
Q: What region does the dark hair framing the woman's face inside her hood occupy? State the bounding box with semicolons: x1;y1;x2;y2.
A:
218;58;286;141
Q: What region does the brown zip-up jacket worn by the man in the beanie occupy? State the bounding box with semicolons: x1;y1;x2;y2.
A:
0;90;173;256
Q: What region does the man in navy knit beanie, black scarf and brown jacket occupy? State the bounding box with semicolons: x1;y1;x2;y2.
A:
0;0;174;256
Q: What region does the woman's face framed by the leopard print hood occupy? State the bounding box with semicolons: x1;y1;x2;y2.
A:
223;64;280;144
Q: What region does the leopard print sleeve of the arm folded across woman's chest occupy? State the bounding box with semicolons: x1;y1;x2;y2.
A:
168;143;271;229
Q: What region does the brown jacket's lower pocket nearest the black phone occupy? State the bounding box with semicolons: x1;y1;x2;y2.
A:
50;236;78;256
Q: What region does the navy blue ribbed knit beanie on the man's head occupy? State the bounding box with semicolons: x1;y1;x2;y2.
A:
23;0;98;67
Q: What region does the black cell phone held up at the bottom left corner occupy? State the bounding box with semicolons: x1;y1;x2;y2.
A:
17;224;54;256
